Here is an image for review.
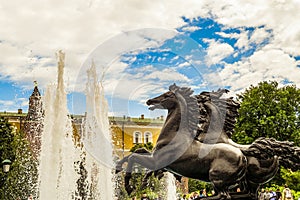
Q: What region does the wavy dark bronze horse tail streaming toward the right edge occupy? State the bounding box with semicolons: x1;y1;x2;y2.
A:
242;137;300;171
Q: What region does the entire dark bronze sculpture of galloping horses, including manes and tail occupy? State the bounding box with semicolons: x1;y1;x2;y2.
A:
116;84;300;199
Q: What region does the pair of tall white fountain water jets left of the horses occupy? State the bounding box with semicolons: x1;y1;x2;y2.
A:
38;51;114;200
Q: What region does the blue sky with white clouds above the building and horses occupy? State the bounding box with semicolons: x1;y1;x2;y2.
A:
0;0;300;117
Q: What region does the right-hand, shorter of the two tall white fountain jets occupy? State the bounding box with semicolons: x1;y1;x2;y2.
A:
82;64;114;200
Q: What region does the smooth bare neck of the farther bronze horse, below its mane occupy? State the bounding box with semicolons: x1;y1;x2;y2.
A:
205;102;229;143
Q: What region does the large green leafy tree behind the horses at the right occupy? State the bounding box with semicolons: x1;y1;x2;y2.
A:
232;81;300;188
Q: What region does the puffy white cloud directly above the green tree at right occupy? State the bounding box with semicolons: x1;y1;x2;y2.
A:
207;46;300;92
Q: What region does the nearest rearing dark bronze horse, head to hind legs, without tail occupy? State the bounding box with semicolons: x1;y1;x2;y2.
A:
117;85;247;199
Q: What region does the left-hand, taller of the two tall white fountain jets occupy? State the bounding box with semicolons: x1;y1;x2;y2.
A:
39;51;79;200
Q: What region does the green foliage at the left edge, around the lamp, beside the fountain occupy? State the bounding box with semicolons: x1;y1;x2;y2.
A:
0;119;37;199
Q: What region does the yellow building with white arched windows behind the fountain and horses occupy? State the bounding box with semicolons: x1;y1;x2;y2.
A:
0;109;164;157
